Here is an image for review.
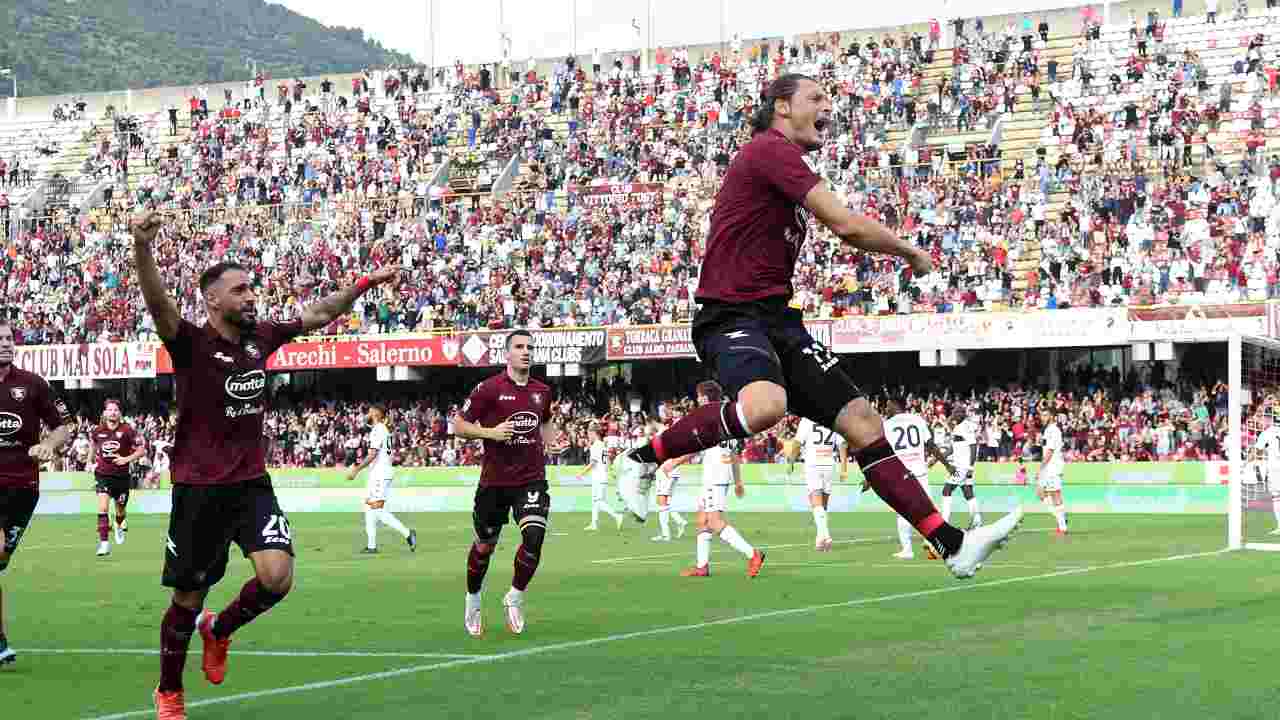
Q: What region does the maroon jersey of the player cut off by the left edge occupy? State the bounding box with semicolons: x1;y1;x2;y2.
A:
0;365;72;488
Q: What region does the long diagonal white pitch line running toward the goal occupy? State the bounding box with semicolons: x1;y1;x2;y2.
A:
88;550;1230;720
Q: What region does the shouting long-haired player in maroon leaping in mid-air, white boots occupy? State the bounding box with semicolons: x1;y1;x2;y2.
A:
614;74;1021;578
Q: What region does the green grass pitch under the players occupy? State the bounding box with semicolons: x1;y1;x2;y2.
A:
0;514;1280;720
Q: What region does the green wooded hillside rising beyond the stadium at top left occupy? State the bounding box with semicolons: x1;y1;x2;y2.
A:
0;0;412;97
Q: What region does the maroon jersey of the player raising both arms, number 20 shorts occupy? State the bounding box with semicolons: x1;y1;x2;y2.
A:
164;320;302;486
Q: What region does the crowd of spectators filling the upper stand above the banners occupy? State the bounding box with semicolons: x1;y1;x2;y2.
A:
0;3;1280;343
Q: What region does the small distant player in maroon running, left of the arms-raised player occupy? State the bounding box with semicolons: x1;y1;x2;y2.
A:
90;398;146;557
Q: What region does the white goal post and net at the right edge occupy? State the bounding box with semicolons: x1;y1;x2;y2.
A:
1226;336;1280;550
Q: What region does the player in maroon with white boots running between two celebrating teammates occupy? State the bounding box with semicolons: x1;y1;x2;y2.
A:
453;331;557;638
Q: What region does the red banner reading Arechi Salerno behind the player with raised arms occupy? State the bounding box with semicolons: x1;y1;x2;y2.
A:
156;336;461;373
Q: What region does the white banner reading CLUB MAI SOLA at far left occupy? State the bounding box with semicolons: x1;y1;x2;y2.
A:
14;342;159;380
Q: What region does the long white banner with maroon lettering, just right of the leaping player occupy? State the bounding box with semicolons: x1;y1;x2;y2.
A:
831;307;1129;352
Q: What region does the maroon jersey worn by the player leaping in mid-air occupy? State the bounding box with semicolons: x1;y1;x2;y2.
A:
695;129;822;302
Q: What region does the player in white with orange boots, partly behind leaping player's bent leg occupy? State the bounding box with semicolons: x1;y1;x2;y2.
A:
680;380;764;578
